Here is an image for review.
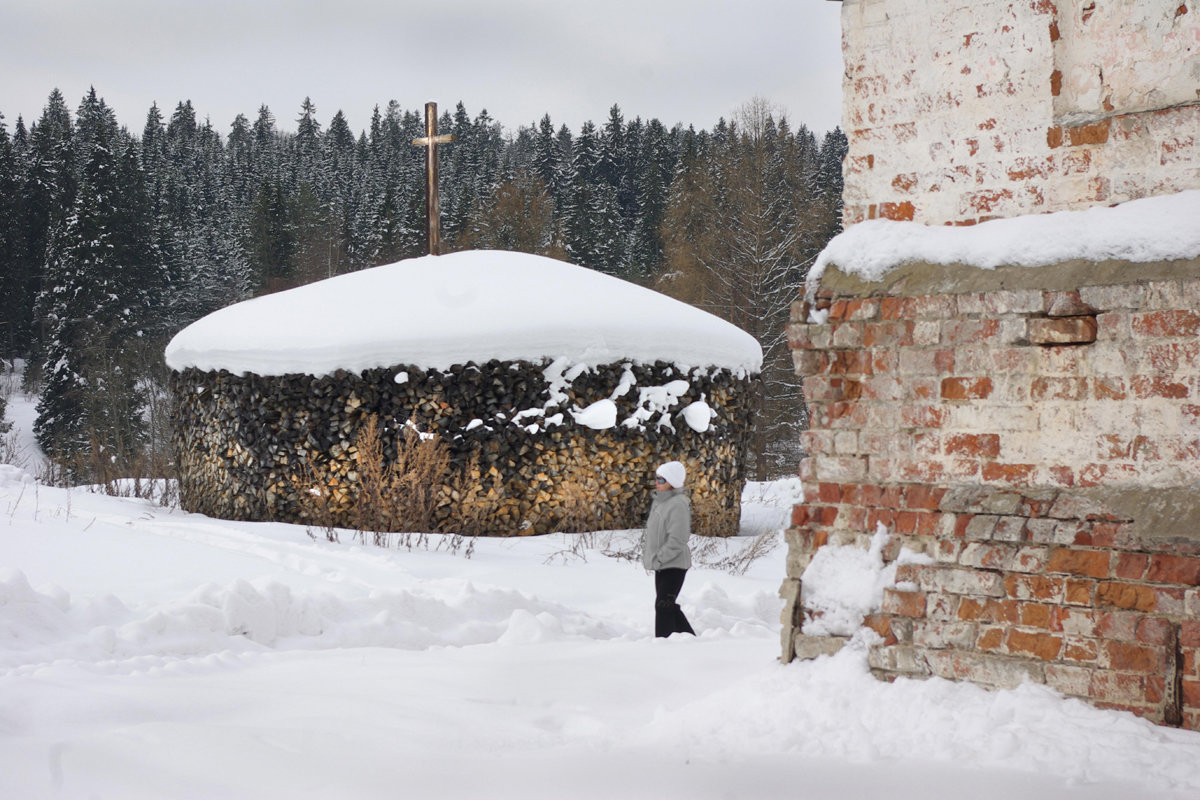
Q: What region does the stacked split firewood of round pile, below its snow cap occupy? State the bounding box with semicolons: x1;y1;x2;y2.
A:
172;360;755;536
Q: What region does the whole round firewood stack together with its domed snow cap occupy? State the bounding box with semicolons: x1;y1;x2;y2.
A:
168;252;761;535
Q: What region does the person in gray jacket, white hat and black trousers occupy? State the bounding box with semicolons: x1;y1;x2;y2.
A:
642;461;696;638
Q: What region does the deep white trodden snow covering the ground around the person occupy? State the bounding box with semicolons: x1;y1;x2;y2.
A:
0;393;1200;800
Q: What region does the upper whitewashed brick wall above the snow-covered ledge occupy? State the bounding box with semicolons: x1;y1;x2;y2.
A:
842;0;1200;225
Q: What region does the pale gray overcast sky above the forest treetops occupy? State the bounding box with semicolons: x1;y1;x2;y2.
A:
0;0;841;137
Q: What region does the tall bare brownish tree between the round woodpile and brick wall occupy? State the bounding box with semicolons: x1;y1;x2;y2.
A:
660;101;830;476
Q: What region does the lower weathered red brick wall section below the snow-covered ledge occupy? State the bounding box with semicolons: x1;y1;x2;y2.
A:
781;260;1200;729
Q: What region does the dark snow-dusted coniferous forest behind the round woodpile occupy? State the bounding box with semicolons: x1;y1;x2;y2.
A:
0;90;846;477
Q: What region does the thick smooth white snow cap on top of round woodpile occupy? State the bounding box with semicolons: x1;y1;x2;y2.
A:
166;251;762;375
